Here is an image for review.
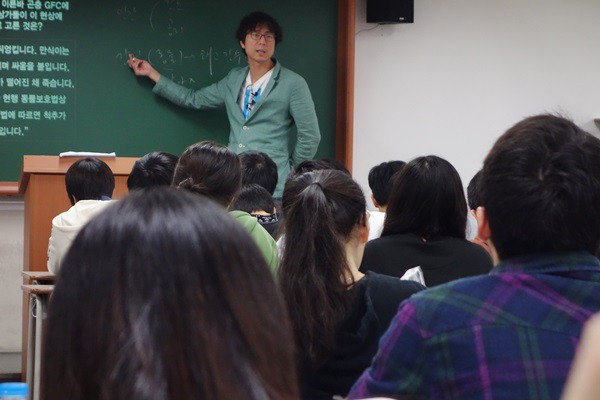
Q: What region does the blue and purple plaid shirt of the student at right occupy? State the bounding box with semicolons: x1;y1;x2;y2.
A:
349;252;600;400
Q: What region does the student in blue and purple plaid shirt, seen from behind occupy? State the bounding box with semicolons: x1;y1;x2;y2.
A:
349;115;600;400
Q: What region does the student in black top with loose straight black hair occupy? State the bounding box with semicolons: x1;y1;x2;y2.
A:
360;156;492;287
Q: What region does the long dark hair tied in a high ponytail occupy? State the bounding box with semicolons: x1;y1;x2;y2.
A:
279;170;366;364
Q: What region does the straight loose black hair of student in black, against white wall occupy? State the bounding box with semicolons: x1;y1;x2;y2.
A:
381;156;467;239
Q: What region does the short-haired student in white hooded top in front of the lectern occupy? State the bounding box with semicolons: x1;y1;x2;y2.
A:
47;157;115;274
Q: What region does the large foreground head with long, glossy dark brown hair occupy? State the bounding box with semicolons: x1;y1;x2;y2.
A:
41;188;296;400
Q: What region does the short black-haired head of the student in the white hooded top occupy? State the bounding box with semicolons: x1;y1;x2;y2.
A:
65;157;115;204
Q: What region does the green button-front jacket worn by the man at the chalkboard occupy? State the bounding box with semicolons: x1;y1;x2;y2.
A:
153;60;321;197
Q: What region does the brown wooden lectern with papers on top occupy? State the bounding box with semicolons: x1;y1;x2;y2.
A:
19;156;137;378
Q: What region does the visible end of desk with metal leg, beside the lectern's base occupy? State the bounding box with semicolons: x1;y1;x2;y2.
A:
21;284;54;400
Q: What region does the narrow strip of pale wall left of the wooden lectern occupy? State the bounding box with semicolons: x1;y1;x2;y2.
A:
0;197;23;376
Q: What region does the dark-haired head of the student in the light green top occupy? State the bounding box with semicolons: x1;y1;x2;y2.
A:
173;141;242;207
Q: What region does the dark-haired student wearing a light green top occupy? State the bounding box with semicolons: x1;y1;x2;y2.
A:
172;141;278;273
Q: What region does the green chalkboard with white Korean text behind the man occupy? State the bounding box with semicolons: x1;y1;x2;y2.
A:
0;0;337;181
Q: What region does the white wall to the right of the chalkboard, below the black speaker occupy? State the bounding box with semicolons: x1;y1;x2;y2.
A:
353;0;600;206
